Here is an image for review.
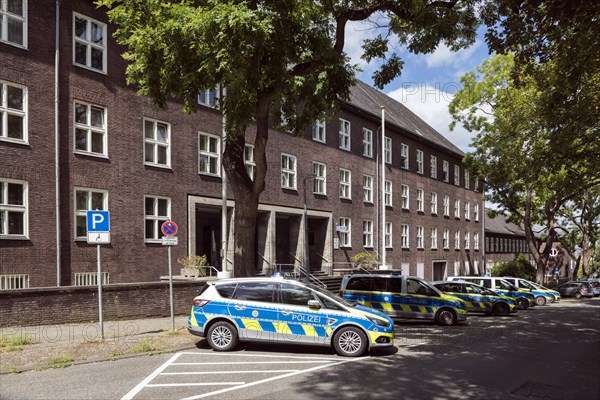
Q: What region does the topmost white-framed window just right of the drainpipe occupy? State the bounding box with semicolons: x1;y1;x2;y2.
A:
73;13;106;72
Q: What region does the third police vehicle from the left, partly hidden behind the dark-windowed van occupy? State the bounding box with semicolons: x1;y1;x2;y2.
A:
431;281;517;316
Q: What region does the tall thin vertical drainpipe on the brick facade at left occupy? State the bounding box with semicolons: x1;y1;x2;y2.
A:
54;0;61;286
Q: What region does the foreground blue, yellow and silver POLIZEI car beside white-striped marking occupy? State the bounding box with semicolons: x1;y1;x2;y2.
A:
188;277;394;357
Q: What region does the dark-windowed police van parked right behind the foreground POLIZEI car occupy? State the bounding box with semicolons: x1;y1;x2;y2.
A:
340;274;467;325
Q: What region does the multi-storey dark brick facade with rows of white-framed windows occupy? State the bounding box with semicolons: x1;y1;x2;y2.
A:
0;0;483;288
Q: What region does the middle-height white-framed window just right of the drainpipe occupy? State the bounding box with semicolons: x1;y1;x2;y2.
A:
74;101;108;156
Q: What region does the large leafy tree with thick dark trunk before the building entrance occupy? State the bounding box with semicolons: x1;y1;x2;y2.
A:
97;0;482;276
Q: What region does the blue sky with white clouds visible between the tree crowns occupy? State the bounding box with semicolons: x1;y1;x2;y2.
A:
344;22;489;152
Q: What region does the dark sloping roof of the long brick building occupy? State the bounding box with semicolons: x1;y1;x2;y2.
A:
349;80;465;157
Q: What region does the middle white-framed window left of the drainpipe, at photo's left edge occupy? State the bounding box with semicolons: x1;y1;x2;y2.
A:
0;80;27;143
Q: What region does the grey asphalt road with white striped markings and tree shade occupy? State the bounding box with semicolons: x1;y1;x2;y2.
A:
0;298;600;400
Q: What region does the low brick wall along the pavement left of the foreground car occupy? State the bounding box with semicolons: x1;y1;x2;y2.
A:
0;280;209;327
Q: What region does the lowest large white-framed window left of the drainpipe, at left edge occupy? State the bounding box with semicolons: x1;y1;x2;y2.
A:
0;178;29;239
